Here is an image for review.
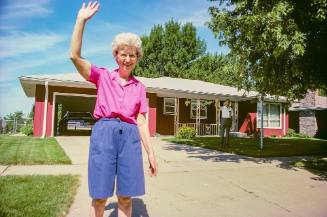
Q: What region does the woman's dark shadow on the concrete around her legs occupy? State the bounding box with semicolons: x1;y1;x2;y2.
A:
105;198;149;217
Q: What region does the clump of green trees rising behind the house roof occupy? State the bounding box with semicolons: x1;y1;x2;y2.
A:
135;20;245;86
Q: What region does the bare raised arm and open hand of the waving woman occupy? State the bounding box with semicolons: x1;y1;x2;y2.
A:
70;1;100;80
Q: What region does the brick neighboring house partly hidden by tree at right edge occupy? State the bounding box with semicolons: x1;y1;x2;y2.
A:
289;90;327;139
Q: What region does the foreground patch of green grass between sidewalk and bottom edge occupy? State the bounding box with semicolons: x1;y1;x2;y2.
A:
0;175;79;217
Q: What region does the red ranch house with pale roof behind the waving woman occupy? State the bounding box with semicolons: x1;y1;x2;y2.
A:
19;73;288;136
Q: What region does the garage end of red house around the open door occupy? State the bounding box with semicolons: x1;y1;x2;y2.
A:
19;73;96;137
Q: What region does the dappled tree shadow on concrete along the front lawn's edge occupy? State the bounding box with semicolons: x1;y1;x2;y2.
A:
163;141;327;181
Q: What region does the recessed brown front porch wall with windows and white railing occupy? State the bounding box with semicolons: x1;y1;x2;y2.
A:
157;96;238;136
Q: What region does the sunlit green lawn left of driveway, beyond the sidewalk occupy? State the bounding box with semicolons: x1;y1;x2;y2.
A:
0;135;71;165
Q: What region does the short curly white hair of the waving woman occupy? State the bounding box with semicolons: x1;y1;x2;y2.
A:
112;32;142;58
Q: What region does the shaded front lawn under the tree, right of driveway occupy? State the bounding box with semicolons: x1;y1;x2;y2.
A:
164;137;327;157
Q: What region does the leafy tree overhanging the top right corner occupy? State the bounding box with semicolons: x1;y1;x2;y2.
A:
208;0;327;98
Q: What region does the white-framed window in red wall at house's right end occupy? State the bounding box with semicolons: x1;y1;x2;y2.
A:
257;102;281;128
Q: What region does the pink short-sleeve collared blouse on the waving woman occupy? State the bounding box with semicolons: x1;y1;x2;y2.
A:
89;64;148;124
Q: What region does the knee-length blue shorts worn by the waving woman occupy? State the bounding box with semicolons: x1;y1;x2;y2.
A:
88;118;145;199
